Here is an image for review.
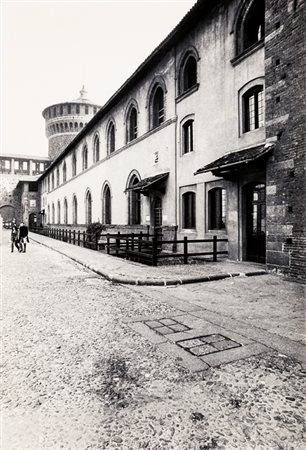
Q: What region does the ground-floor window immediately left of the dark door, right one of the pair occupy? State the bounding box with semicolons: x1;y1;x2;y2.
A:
208;188;226;230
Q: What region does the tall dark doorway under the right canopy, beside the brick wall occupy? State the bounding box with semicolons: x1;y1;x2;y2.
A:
246;183;266;263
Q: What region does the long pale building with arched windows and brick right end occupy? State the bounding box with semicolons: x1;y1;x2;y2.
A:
39;0;306;280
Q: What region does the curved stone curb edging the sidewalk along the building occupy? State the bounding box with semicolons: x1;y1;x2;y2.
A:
31;236;268;286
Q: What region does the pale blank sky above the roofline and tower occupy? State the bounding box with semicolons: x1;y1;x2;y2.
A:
1;0;196;156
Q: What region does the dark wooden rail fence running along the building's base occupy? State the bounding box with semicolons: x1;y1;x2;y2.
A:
30;228;228;266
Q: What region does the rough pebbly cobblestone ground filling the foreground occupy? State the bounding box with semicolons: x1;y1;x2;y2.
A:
1;234;305;450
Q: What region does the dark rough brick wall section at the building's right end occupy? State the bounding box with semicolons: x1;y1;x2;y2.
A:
265;0;306;281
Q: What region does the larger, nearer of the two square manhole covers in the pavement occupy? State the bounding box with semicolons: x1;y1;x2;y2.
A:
176;334;241;356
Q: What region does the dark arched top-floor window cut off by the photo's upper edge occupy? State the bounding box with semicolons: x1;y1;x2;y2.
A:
236;0;265;55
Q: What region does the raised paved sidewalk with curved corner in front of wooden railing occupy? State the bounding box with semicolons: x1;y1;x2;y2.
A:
30;233;266;286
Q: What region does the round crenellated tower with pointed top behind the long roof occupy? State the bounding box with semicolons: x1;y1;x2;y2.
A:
42;86;100;160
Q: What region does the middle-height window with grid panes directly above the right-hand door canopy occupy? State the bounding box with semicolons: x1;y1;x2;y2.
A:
242;85;264;133
